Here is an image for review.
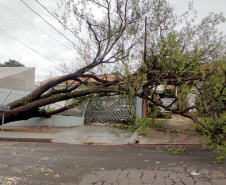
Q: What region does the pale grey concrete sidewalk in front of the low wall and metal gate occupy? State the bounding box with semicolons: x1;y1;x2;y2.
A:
0;125;131;145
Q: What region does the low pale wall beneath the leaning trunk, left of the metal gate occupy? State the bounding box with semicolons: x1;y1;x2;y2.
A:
5;115;84;127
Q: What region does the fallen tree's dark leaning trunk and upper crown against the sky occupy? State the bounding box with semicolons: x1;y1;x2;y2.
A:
1;0;225;123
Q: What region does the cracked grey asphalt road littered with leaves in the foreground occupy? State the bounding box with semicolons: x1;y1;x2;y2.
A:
0;142;226;185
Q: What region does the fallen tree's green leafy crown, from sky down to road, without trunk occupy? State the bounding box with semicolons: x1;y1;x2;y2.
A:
59;0;226;163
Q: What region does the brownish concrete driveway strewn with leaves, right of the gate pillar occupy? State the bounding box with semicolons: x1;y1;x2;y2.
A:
136;114;207;145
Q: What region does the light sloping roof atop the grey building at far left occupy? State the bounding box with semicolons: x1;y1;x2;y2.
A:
0;67;34;78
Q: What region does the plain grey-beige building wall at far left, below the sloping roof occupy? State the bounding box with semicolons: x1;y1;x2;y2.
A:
0;68;36;91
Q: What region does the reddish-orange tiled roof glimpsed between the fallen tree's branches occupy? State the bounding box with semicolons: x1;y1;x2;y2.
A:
40;75;117;85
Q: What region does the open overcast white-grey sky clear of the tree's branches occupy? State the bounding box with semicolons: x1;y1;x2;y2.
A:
0;0;226;81
